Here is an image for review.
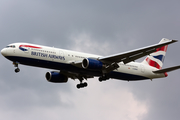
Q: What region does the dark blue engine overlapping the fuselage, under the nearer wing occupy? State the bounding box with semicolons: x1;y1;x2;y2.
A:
82;58;103;70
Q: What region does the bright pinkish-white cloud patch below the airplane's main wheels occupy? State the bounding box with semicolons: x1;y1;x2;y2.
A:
69;81;148;120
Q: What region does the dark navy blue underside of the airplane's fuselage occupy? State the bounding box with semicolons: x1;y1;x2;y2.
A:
6;56;149;81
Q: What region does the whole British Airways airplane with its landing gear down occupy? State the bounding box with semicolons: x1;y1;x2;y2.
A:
1;38;180;89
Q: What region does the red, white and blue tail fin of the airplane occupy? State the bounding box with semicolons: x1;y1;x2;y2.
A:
142;38;169;69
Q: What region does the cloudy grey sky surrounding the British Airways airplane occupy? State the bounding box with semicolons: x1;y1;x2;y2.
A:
0;0;180;120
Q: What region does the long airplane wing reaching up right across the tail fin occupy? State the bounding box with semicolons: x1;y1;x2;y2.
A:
98;40;177;64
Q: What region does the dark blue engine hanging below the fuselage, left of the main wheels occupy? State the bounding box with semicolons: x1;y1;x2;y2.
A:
46;71;68;83
